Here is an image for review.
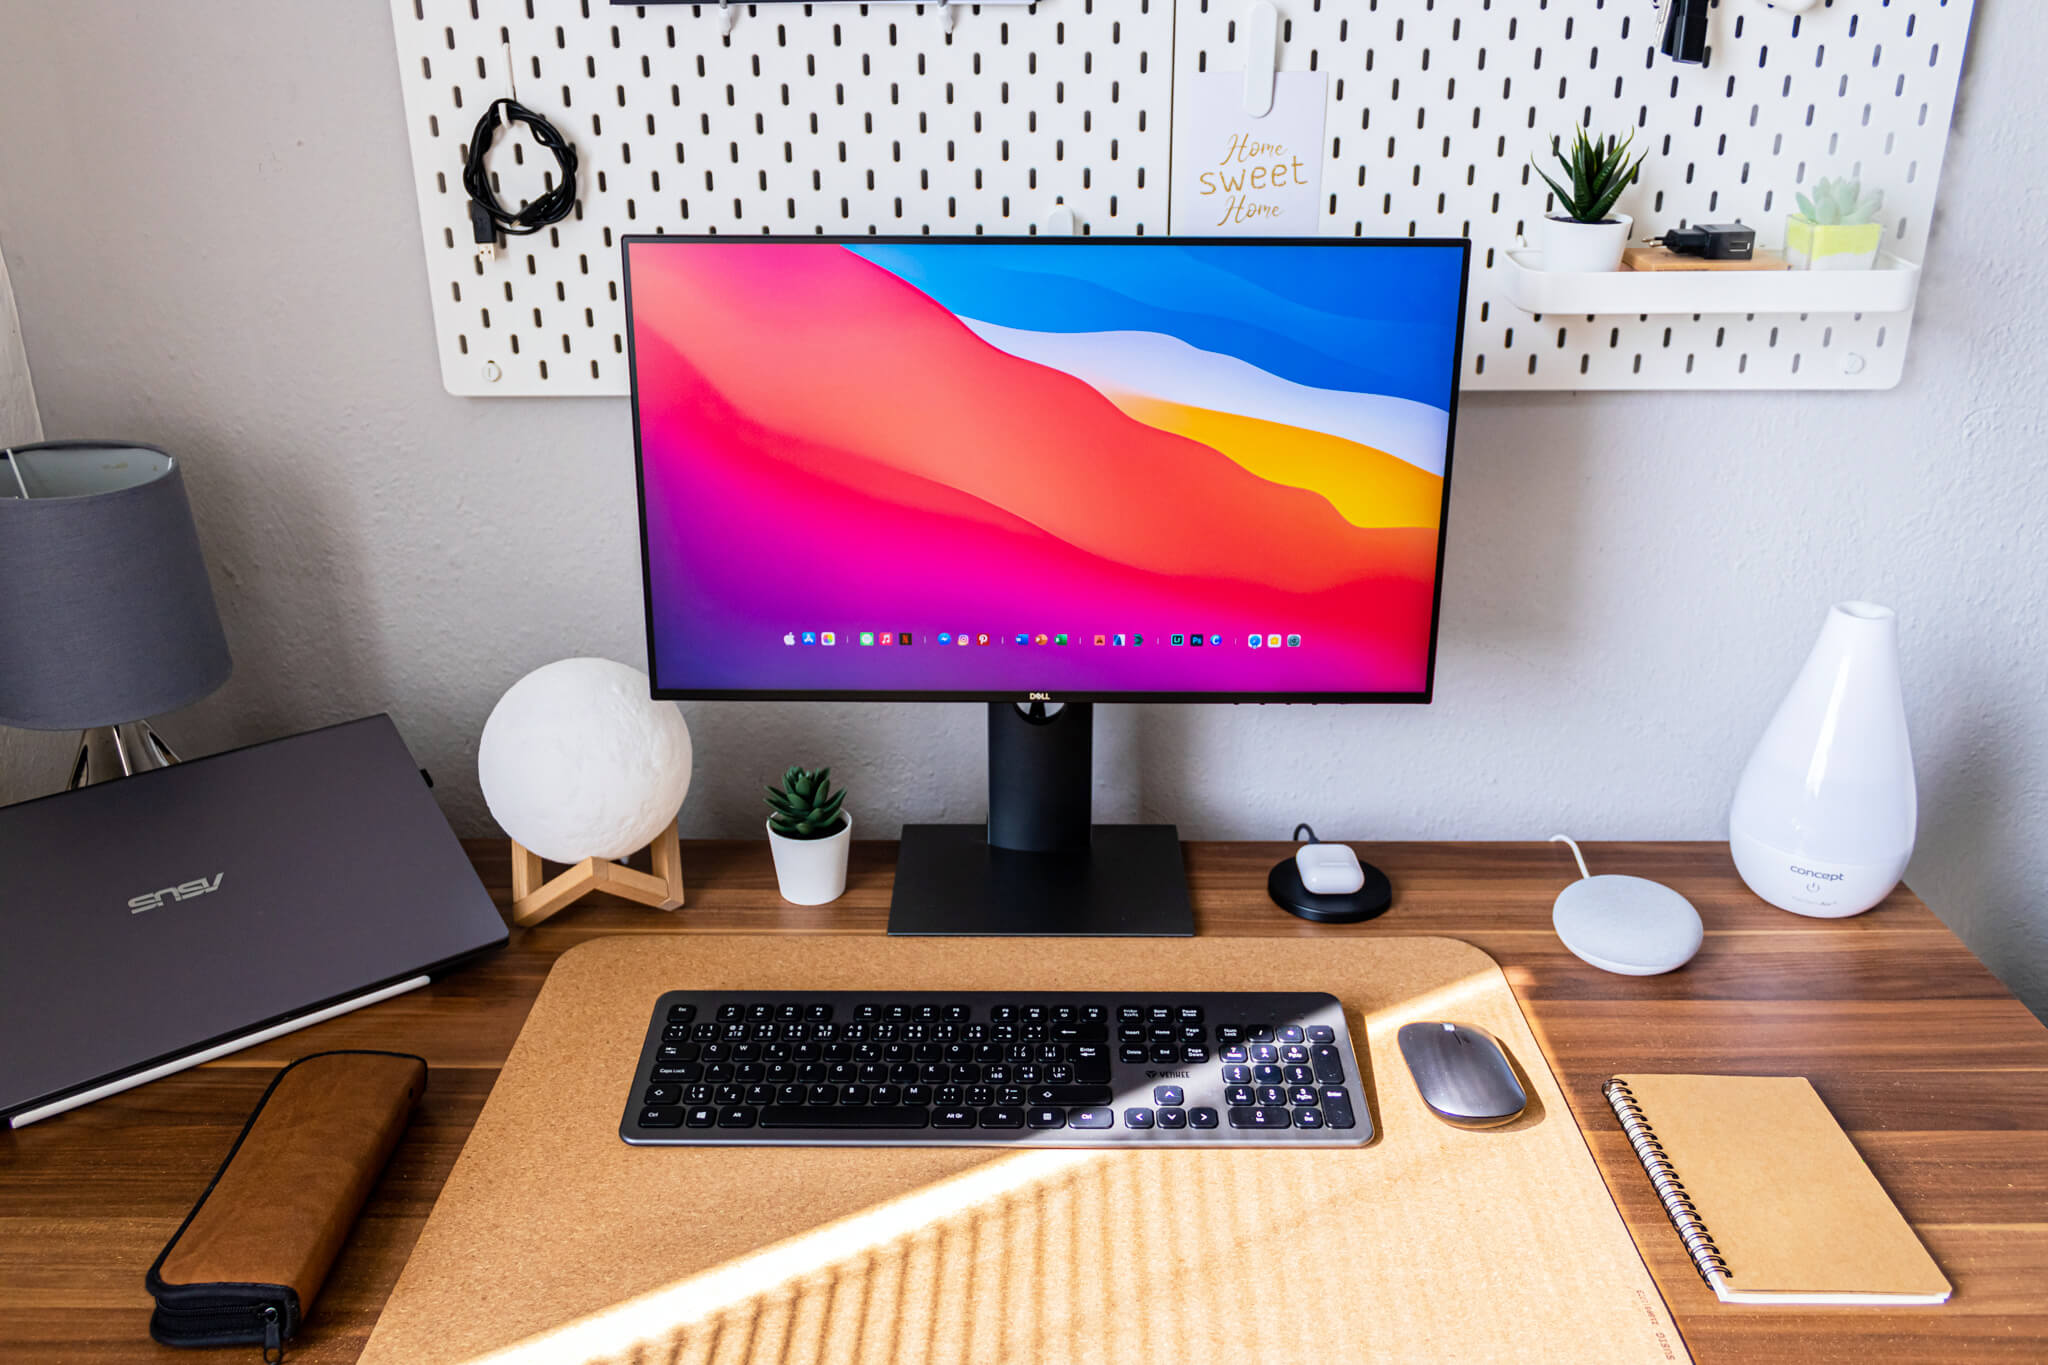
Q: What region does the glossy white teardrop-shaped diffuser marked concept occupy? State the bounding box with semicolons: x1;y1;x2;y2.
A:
1729;602;1919;919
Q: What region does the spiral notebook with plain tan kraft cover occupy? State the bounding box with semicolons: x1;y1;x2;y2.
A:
1602;1076;1950;1306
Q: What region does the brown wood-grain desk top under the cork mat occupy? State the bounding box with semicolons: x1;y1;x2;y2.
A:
0;841;2048;1365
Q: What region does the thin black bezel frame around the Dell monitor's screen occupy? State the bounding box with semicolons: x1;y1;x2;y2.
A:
618;233;1473;706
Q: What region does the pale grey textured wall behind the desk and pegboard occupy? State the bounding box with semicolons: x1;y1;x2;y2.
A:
0;0;2048;1009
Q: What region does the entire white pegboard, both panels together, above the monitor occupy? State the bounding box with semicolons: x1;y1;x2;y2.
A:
391;0;1970;395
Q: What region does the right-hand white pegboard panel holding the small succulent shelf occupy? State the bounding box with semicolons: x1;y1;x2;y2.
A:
1176;0;1970;389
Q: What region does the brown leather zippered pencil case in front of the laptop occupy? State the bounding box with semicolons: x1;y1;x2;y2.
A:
143;1052;426;1361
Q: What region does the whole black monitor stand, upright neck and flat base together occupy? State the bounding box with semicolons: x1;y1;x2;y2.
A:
889;702;1194;937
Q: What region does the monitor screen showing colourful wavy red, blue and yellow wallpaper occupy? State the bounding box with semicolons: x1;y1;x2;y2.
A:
627;237;1464;696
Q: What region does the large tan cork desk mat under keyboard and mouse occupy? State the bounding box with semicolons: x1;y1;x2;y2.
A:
362;935;1688;1365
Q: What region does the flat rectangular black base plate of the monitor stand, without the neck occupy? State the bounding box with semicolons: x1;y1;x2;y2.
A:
889;825;1194;941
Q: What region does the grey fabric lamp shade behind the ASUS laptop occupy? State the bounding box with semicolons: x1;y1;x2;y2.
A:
0;440;233;731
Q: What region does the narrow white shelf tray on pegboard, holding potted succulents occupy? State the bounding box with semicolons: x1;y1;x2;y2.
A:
1505;252;1919;317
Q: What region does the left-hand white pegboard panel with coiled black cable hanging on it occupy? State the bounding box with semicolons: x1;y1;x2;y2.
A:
391;0;1174;395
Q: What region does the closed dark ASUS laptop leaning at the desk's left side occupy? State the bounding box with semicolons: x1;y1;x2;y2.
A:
0;716;506;1128
